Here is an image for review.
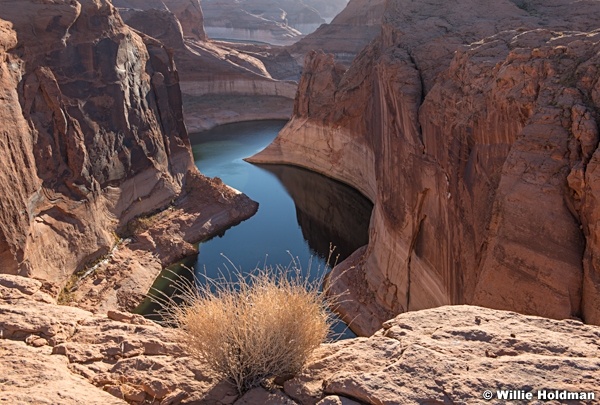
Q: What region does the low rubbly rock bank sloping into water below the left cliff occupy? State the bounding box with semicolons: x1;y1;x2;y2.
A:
68;174;258;313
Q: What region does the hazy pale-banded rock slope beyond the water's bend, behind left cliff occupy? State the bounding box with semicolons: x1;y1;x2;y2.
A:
115;0;296;132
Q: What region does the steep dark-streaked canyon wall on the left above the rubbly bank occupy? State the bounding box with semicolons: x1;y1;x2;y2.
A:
0;0;255;291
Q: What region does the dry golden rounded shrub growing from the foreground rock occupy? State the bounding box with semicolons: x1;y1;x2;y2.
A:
168;267;331;393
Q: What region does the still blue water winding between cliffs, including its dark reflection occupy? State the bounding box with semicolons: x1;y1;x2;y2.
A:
142;121;373;337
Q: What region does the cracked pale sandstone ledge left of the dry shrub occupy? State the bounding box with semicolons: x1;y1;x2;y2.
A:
0;275;237;404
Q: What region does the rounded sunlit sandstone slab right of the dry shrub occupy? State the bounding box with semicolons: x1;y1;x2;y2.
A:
285;306;600;405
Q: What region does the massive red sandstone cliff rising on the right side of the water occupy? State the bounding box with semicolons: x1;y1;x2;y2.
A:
253;1;600;334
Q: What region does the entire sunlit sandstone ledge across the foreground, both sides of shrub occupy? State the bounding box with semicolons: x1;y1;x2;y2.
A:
0;275;600;405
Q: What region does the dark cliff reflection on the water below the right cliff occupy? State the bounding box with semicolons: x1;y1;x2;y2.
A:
256;164;373;264
